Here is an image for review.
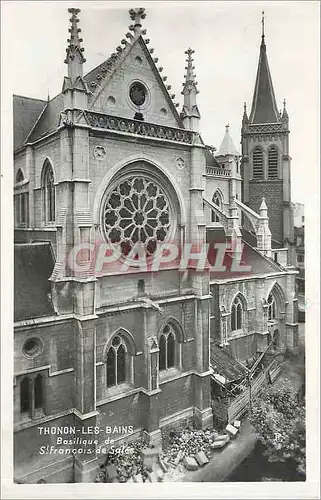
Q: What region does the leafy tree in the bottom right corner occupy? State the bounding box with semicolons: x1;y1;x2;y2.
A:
250;382;306;475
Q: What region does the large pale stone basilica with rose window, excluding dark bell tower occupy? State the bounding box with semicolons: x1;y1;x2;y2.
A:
13;9;298;483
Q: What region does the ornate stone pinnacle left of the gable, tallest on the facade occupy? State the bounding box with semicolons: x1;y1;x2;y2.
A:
64;8;86;80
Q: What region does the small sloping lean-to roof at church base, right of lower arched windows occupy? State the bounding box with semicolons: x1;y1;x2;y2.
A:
210;344;247;384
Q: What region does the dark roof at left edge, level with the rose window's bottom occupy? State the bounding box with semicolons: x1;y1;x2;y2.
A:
14;243;55;321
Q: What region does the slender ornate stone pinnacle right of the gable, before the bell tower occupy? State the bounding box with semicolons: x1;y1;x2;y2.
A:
181;48;201;131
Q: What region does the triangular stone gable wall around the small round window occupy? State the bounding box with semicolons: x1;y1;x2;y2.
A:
85;36;183;128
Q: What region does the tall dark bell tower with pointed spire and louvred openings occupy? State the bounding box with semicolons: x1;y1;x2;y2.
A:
242;12;294;261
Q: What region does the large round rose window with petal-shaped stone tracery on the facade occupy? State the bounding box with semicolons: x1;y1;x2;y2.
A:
103;176;171;255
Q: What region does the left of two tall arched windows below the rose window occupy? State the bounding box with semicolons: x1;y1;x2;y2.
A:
107;335;127;387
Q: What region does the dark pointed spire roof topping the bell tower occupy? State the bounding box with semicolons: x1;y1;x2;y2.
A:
249;13;280;123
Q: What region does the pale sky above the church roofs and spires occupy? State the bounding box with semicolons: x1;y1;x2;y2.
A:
2;1;320;203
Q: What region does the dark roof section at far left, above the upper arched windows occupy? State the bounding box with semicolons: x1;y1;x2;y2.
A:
13;95;47;151
